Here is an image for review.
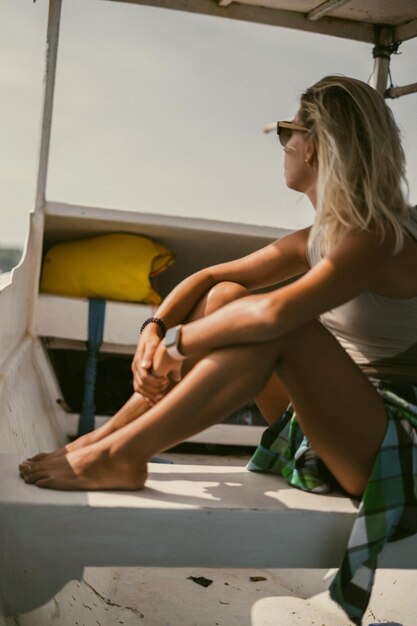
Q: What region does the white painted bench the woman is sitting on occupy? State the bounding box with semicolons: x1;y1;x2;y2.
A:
0;455;416;615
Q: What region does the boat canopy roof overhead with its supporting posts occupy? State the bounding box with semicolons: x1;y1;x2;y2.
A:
35;0;417;213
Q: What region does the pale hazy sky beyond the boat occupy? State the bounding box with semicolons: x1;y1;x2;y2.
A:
0;0;417;247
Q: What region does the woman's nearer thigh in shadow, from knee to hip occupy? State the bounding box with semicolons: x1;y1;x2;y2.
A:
277;322;387;495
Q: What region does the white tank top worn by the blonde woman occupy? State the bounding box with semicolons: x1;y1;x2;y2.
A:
307;207;417;383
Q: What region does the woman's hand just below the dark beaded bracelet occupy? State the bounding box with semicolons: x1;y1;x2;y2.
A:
132;324;169;404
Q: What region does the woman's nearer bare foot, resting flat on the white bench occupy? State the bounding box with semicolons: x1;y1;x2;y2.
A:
19;444;147;491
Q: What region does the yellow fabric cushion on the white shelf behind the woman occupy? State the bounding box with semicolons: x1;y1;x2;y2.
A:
40;233;175;304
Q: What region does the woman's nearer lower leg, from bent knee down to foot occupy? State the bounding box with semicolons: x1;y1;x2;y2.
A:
20;338;282;489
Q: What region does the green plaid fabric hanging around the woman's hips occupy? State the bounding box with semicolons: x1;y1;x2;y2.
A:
247;381;417;625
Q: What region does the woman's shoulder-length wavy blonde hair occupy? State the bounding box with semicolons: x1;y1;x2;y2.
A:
300;76;410;251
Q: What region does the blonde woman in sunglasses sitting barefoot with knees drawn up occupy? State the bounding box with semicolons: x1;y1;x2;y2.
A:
20;76;417;615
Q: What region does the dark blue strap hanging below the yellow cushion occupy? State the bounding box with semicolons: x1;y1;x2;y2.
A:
78;298;106;437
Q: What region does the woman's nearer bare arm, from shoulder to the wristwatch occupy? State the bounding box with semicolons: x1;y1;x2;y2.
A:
171;233;393;355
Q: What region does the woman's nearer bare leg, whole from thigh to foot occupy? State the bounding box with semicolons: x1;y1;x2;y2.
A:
21;322;386;495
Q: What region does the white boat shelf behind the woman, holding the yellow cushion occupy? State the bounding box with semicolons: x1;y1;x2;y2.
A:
34;203;282;446
